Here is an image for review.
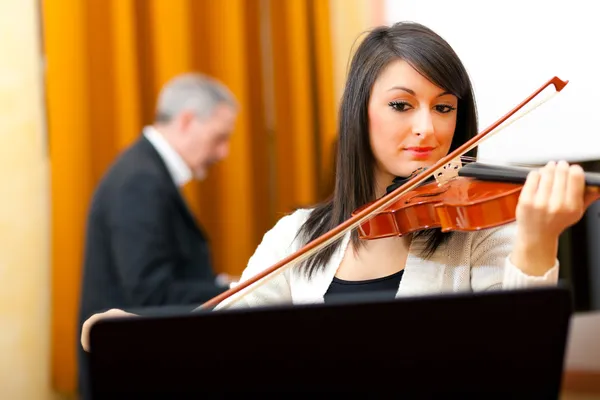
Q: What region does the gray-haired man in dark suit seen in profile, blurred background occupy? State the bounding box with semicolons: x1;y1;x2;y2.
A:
79;74;238;398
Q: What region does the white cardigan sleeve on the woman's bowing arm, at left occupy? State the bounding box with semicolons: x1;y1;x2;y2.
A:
215;210;308;309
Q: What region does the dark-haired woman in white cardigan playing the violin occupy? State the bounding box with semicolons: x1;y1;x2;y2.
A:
82;23;585;347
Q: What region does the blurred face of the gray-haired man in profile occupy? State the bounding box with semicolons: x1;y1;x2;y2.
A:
184;104;237;180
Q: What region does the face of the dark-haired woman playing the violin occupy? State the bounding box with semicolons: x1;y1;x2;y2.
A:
369;60;458;192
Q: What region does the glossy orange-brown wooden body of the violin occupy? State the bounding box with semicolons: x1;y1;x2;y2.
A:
354;177;523;240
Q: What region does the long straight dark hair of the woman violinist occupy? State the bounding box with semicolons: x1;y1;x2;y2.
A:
298;22;478;276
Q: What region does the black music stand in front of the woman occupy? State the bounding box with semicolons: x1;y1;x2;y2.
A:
90;287;572;399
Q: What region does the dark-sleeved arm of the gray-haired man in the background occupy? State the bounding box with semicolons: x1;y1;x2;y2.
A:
109;176;226;307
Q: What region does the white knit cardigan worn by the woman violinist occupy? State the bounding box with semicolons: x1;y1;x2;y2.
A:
216;209;559;309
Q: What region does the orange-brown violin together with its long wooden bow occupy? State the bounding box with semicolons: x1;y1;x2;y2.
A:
200;77;600;308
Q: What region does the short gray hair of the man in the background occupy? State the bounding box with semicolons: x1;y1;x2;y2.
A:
155;73;237;123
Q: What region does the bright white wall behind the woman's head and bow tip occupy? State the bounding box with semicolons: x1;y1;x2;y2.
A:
386;0;600;162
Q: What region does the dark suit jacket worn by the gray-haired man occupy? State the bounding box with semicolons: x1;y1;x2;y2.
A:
78;135;225;398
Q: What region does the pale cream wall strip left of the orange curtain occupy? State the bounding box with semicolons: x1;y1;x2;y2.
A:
0;0;50;400
